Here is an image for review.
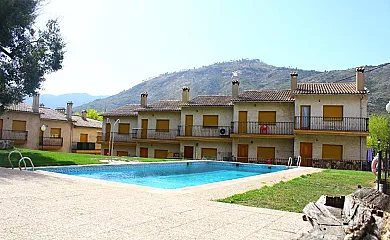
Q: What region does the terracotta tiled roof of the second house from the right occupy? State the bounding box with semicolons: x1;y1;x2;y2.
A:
233;90;294;102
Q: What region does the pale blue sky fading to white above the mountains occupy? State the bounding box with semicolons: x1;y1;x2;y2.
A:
37;0;390;95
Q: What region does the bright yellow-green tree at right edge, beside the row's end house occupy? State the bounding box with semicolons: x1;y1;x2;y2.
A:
367;114;389;151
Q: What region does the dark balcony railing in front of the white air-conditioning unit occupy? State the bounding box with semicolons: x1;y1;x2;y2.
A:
179;125;230;137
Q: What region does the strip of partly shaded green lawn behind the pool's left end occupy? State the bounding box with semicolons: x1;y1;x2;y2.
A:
0;148;181;167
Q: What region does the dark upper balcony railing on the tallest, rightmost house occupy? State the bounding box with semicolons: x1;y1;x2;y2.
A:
295;116;368;132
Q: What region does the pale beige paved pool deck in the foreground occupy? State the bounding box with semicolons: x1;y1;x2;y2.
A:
0;168;321;239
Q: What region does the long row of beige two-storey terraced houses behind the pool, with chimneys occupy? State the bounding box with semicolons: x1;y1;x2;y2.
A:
102;67;368;166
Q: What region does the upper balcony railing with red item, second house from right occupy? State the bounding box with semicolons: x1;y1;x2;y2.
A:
232;122;294;135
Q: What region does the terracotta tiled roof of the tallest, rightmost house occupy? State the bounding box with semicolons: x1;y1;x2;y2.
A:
292;82;367;95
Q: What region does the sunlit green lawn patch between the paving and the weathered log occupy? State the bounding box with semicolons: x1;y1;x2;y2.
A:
218;170;375;213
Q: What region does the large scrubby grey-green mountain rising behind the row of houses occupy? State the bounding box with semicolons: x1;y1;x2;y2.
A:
76;59;390;112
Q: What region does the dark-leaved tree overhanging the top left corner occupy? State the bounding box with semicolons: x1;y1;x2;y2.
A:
0;0;65;113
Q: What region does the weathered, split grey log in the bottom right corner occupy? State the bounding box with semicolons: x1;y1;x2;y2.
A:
299;188;390;240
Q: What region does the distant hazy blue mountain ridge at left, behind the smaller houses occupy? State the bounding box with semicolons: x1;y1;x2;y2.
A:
25;93;108;108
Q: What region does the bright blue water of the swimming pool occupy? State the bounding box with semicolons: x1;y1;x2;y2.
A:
39;161;287;189
